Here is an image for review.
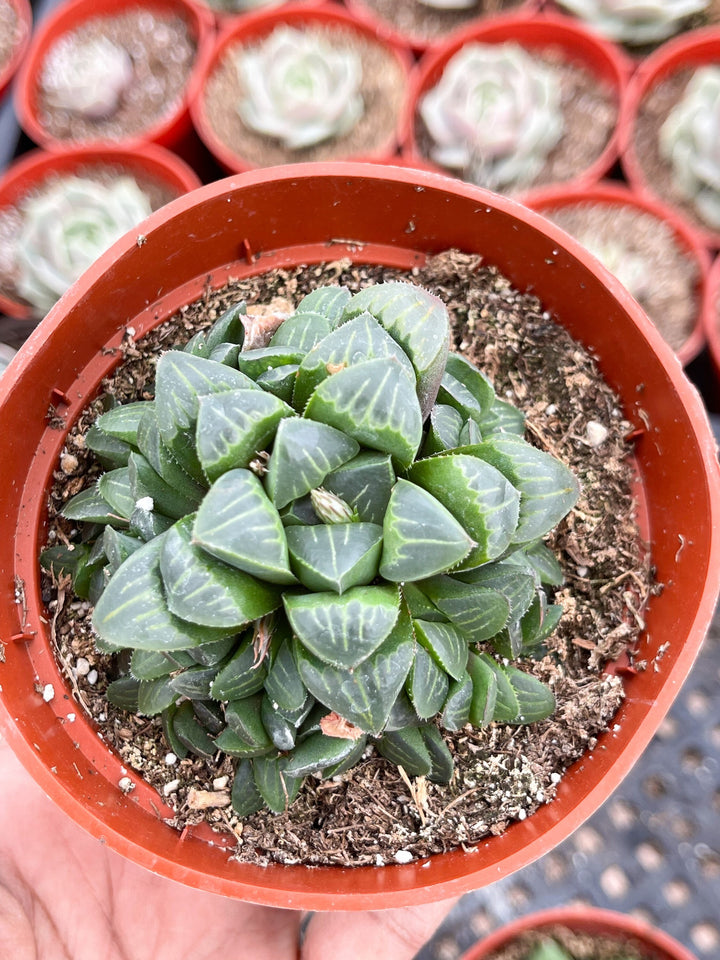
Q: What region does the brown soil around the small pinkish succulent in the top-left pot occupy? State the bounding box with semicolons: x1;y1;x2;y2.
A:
37;7;196;142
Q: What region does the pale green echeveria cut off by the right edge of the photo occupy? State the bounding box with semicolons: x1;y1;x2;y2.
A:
659;66;720;229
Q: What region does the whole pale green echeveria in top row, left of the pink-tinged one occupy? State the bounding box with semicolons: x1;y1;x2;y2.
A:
236;26;364;150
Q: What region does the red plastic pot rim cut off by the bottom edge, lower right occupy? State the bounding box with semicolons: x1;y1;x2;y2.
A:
462;907;696;960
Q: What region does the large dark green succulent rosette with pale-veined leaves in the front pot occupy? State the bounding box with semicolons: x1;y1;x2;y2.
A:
43;282;578;816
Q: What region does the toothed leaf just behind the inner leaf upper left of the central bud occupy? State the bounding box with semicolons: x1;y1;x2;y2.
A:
195;390;294;484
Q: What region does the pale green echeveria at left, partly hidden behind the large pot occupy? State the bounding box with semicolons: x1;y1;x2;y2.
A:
15;176;152;315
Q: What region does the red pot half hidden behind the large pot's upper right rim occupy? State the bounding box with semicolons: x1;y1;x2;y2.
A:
523;182;710;366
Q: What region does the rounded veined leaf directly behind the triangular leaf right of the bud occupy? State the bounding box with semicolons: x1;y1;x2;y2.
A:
408;453;520;569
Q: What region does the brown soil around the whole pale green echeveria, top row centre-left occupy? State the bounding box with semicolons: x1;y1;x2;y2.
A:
203;26;407;167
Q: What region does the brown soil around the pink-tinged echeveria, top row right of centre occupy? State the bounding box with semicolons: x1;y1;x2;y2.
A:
415;48;618;194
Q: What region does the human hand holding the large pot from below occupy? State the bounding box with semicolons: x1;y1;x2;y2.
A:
0;739;454;960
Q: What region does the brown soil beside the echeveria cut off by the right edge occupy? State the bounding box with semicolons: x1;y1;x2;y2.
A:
633;68;714;229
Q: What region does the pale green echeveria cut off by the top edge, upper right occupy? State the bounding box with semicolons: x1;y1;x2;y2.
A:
559;0;710;46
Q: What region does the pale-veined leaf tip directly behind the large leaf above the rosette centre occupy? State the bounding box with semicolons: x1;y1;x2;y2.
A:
293;313;415;412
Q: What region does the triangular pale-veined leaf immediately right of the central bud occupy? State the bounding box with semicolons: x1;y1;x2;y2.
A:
380;479;475;583
